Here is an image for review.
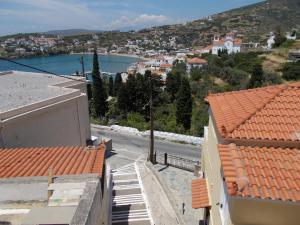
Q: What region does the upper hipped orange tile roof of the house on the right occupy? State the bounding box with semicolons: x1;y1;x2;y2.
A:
206;82;300;142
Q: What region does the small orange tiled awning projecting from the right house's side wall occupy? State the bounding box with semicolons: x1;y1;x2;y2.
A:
192;179;210;209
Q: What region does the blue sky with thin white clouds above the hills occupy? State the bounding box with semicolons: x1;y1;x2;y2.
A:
0;0;260;35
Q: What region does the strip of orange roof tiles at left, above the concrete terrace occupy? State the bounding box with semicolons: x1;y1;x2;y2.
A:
0;145;105;178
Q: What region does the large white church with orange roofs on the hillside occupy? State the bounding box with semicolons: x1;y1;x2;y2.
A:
212;32;242;55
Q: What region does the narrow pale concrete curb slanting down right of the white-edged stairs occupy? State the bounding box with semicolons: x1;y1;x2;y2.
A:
144;162;185;225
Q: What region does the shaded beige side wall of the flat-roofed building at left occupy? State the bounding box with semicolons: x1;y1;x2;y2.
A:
0;94;90;148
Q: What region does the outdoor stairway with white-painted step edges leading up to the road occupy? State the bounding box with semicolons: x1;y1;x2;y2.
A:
112;163;152;225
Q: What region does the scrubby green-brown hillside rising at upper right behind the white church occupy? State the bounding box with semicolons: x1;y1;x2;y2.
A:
139;0;300;47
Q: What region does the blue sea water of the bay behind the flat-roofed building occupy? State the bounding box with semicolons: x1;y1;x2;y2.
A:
0;54;139;75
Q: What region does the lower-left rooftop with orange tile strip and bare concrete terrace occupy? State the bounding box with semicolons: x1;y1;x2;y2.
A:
0;144;105;225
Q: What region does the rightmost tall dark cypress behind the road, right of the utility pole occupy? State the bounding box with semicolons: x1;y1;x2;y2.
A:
176;78;193;130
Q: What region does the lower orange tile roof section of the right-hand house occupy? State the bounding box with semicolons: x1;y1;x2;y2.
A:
218;144;300;202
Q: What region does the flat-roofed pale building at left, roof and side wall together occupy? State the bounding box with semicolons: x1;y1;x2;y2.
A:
0;71;91;148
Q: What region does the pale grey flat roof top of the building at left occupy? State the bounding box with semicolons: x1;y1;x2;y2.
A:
0;71;83;114
